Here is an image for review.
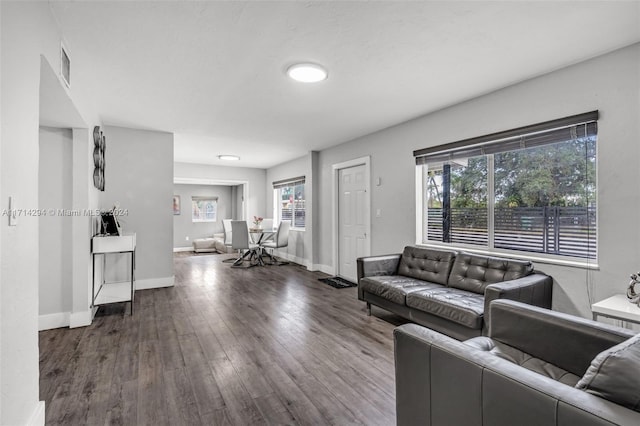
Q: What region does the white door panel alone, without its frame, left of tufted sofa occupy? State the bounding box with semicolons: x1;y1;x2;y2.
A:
338;165;369;282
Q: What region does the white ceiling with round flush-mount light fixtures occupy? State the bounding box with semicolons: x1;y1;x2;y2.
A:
51;1;640;168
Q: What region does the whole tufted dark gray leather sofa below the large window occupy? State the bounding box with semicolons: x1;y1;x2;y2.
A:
357;246;552;340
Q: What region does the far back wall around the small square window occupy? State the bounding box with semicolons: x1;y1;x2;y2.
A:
173;185;235;248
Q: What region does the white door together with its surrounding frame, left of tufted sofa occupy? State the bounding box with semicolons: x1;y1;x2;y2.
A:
333;157;371;282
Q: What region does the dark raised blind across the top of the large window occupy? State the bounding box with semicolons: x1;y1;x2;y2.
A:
413;111;598;165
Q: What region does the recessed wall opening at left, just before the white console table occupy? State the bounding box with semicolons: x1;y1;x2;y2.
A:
36;56;90;330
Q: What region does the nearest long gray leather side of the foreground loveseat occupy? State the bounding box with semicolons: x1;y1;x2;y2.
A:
394;324;640;426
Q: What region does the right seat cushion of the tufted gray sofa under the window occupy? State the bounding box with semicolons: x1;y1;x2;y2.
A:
407;287;484;330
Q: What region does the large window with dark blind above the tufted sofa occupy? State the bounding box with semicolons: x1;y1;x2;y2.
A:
414;111;598;259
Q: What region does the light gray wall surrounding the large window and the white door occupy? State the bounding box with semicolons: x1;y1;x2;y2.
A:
314;44;640;317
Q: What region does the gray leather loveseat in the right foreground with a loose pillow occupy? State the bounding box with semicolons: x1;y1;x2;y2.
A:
394;300;640;426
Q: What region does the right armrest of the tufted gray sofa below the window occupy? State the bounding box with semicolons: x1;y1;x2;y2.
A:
483;273;553;334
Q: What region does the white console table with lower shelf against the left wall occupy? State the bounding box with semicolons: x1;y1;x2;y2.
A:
91;233;136;315
